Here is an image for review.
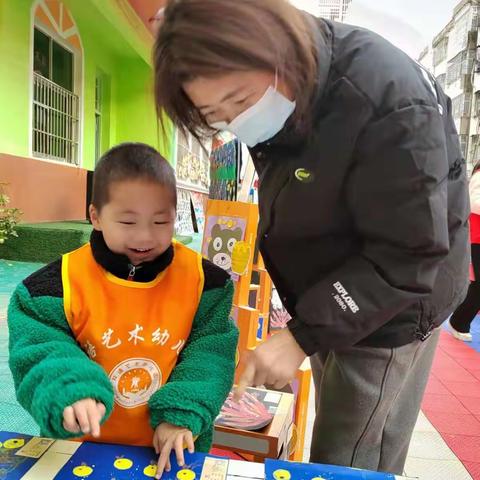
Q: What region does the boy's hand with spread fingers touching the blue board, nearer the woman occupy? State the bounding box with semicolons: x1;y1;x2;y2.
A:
153;423;195;478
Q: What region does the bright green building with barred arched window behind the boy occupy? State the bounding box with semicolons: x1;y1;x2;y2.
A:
0;0;174;222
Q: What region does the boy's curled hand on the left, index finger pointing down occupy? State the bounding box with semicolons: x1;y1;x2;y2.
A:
63;398;106;438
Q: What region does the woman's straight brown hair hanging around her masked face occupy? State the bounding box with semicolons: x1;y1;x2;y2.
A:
154;0;317;138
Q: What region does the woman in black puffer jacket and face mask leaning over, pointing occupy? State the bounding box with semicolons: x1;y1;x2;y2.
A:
155;0;468;473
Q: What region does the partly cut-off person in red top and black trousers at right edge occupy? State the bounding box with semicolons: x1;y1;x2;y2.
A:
450;163;480;342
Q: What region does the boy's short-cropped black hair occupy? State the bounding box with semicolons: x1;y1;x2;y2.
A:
92;142;177;211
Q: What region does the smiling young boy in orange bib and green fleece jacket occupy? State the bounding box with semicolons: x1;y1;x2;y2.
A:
8;143;237;478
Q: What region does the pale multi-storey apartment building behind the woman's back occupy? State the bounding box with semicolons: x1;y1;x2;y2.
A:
419;0;480;173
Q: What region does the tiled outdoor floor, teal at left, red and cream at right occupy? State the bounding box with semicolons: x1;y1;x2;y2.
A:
0;260;480;480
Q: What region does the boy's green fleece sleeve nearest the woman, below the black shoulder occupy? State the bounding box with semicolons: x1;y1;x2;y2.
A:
149;280;238;436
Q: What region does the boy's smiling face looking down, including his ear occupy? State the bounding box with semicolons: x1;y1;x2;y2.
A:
90;179;176;265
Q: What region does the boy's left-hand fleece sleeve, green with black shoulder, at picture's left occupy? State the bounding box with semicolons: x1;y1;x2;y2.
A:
8;260;113;438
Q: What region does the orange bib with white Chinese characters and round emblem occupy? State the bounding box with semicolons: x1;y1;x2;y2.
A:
62;242;204;446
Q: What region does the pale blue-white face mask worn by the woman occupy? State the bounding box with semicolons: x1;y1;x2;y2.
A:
210;73;296;147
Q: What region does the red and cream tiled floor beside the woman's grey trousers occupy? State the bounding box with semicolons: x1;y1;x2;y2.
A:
304;324;480;480
